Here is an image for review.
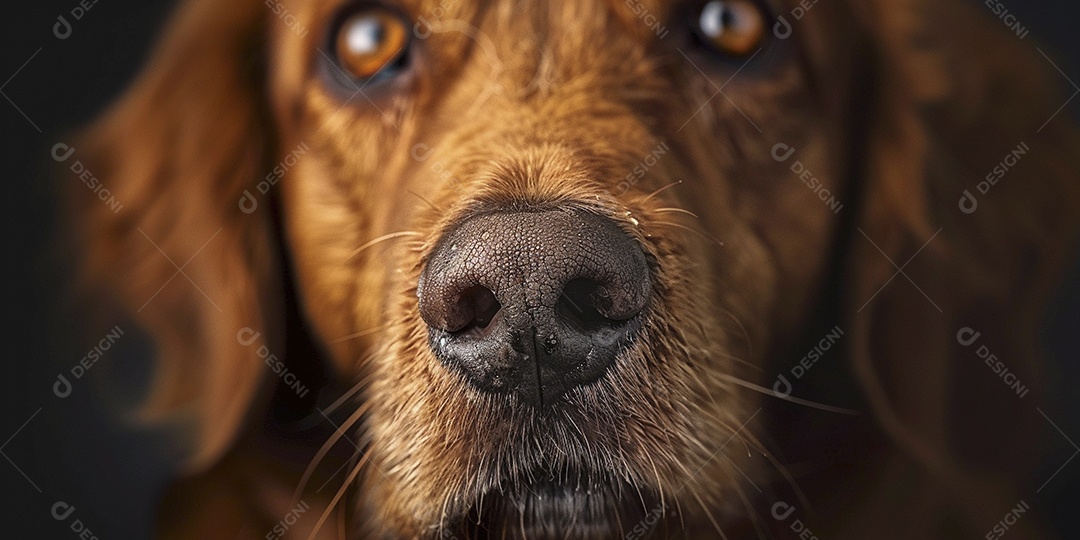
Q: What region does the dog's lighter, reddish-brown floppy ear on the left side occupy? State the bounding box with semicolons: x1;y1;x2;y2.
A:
73;0;280;471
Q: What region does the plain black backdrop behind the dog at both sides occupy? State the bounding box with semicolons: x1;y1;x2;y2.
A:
0;0;1080;539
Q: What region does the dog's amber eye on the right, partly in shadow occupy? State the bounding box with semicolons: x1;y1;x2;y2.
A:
697;0;767;56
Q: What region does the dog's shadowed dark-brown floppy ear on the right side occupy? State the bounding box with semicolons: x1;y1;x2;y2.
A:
845;0;1080;536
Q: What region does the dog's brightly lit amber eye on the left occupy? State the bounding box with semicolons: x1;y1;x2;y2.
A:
334;8;409;80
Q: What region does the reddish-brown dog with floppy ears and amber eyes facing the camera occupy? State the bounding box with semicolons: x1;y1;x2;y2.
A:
71;0;1080;539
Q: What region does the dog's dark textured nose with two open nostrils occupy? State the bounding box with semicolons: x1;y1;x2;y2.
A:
417;210;651;406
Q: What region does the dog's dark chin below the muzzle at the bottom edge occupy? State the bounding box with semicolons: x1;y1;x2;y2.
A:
459;473;661;539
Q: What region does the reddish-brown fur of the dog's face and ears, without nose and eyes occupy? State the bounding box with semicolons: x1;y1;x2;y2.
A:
71;0;1080;538
